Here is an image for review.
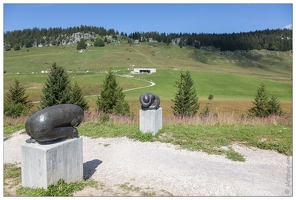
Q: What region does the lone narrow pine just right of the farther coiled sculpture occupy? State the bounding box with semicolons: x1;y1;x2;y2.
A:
172;71;199;118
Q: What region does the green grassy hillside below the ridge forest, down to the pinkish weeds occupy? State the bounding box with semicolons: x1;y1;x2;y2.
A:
4;43;292;115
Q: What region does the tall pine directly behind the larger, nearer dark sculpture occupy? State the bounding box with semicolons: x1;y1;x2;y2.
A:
40;63;71;109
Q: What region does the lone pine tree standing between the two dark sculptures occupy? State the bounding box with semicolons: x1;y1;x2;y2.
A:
96;70;130;115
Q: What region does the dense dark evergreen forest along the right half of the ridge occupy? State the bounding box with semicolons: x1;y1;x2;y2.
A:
129;29;293;51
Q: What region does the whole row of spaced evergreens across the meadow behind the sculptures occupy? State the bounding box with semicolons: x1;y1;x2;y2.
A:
4;63;283;118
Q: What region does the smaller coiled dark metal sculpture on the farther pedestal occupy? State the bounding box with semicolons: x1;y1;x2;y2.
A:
140;92;160;110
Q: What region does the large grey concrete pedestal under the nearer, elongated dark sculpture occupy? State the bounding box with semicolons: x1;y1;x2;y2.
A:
21;137;83;189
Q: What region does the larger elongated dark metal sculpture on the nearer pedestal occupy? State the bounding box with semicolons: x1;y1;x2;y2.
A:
25;104;84;143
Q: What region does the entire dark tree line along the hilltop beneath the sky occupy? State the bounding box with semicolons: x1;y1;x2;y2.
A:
4;25;292;51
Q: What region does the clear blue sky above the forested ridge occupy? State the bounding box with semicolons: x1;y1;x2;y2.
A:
3;2;292;34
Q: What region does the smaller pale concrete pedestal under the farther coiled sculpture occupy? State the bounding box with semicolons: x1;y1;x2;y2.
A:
140;108;162;135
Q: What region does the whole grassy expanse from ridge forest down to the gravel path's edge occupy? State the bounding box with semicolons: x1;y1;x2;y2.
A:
3;40;292;161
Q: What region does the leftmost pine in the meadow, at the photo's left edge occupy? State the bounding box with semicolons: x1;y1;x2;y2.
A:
4;79;33;117
